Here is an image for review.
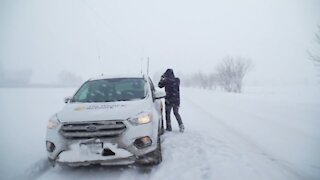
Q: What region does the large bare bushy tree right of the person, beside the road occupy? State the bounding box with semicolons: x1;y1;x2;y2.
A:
216;56;252;93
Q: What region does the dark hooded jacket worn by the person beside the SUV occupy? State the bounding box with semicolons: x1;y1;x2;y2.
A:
158;69;180;106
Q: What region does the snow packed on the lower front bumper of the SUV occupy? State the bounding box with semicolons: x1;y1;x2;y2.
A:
57;141;134;164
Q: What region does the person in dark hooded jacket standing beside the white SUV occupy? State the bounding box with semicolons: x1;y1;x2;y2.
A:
158;69;184;132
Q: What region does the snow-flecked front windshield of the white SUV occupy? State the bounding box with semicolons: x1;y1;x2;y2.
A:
71;78;148;102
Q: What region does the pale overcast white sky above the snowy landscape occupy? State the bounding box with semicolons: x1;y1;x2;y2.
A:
0;0;320;82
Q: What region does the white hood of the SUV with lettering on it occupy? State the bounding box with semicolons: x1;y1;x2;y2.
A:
57;99;151;122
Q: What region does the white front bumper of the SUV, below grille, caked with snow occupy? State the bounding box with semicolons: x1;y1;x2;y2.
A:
47;121;158;166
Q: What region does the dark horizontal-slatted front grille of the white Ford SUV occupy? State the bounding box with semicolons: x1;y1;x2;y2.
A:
60;120;126;139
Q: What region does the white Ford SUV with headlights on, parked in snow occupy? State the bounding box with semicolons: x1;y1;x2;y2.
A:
46;75;165;166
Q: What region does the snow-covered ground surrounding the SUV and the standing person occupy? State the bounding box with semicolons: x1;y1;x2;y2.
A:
0;87;320;180
